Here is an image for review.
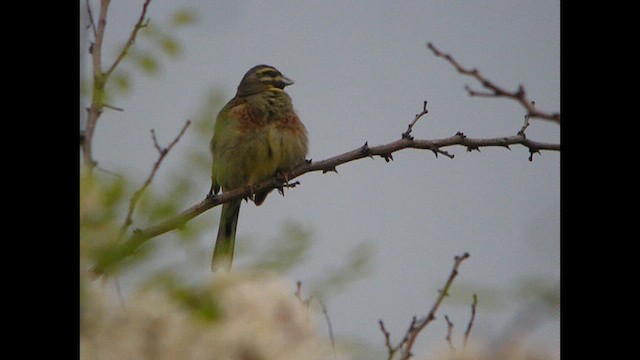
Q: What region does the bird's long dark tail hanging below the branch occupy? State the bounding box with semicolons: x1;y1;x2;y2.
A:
211;200;242;271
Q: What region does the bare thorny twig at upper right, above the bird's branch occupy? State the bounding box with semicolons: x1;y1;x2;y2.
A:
427;43;560;124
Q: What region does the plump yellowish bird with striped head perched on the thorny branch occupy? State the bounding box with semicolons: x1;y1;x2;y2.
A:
210;65;308;271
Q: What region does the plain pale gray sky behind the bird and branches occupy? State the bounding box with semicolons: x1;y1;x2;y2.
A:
81;0;560;353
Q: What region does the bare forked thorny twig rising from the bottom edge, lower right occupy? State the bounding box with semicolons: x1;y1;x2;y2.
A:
379;253;469;360
